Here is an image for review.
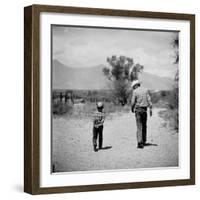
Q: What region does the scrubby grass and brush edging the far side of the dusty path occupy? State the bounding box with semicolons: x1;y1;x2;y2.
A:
52;90;178;130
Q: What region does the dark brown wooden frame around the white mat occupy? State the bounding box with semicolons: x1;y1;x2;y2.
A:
24;5;195;194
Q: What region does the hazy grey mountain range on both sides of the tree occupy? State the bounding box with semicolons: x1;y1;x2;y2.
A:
52;60;173;90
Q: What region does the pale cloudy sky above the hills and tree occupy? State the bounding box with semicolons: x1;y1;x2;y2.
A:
52;26;178;78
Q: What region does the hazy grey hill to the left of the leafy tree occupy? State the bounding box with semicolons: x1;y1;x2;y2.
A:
52;60;109;90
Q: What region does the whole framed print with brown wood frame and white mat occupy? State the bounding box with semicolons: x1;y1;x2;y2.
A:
24;5;195;194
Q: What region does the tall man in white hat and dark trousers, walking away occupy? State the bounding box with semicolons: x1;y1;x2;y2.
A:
131;80;152;148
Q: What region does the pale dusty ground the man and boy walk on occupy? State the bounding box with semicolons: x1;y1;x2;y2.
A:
52;109;178;172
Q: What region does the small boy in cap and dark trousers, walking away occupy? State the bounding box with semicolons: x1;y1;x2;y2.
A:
93;102;105;152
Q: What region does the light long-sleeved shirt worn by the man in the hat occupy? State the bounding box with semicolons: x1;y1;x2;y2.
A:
131;86;152;108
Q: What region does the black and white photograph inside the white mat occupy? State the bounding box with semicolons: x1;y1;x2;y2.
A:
51;25;180;173
